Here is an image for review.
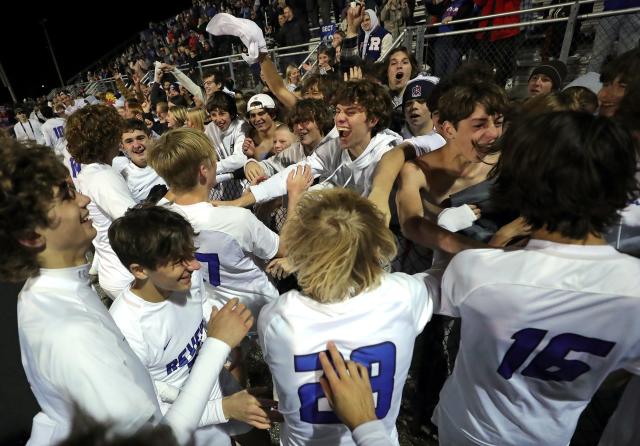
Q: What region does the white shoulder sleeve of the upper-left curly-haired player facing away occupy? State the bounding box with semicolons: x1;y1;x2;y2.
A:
83;168;136;220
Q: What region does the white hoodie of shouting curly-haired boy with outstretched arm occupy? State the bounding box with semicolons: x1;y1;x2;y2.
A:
251;129;402;203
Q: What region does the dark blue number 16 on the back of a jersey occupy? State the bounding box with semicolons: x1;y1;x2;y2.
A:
498;328;616;381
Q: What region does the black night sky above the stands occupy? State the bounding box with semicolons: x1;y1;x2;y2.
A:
0;0;191;104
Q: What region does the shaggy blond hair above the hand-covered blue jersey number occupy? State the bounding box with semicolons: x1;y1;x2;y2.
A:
282;189;396;303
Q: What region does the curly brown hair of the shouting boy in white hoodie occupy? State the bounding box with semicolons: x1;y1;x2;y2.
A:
332;79;393;136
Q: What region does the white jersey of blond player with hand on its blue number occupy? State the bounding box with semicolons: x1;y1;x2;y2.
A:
258;273;440;446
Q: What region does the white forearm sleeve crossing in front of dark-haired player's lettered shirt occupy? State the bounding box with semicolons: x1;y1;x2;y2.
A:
164;338;231;444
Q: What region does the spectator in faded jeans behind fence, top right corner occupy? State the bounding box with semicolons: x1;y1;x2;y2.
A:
588;0;640;72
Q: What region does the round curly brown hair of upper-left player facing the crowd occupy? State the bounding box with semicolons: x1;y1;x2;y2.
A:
64;104;124;164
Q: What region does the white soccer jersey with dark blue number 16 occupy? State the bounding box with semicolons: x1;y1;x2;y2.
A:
434;240;640;446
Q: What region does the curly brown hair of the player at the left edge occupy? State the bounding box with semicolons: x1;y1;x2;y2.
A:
0;138;69;282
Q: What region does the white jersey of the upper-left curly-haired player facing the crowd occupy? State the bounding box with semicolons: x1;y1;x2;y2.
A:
76;163;136;299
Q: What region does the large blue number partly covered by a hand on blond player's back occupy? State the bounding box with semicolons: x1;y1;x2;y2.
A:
293;342;396;424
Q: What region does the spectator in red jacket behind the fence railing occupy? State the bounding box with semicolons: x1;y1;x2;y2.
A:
473;0;520;87
